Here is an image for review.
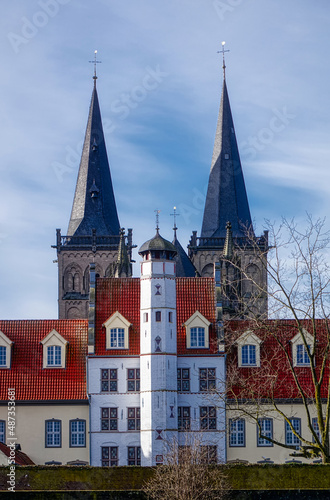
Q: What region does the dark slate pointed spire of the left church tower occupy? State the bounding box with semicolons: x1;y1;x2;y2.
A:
68;79;120;236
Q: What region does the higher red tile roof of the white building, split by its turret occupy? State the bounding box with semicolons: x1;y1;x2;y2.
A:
95;278;216;356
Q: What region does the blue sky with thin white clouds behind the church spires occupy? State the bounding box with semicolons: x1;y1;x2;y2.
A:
0;0;330;319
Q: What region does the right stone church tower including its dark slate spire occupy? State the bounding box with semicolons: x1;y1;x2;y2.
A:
188;65;268;318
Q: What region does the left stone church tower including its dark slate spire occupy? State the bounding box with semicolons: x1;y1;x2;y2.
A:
55;74;133;319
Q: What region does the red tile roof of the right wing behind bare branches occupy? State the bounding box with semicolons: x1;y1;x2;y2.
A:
226;320;329;400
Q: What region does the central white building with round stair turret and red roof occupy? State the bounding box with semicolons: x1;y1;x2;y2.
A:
87;230;226;466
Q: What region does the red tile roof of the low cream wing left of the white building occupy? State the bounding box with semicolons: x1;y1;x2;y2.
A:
0;319;88;401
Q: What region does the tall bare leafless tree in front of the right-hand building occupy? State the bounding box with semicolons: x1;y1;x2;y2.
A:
225;215;330;463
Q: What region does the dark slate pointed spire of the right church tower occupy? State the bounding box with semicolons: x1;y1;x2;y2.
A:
201;79;252;238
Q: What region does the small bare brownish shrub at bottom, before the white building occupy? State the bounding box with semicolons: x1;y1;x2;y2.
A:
143;432;228;500
